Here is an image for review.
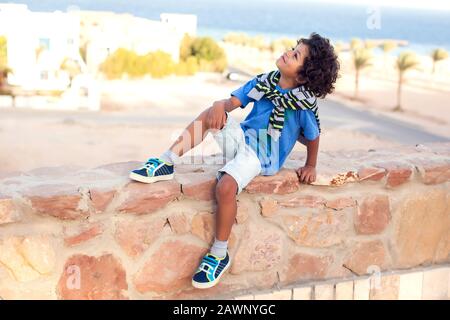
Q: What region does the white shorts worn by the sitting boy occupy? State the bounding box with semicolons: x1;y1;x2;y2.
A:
212;112;262;194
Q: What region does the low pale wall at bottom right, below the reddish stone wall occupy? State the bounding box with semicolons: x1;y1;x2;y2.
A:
232;264;450;300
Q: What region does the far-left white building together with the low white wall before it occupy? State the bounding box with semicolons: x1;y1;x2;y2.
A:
0;3;100;110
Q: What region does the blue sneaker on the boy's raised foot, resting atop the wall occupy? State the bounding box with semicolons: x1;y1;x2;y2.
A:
130;158;173;183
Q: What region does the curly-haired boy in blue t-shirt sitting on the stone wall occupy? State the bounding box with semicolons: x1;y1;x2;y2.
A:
130;33;339;288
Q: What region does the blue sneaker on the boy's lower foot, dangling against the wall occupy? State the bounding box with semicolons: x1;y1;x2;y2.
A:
192;251;231;289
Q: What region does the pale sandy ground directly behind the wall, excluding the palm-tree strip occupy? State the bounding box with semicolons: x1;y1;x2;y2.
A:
0;75;396;174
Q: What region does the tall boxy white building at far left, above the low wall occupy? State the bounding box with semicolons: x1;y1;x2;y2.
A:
0;4;86;90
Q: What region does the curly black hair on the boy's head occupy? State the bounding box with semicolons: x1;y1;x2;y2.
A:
297;32;340;98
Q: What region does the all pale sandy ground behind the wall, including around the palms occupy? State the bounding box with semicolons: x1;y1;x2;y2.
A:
0;47;450;175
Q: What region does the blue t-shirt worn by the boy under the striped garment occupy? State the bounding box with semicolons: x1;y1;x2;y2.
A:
231;77;319;176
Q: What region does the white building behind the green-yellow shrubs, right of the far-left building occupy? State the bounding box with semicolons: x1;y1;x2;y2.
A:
77;11;197;72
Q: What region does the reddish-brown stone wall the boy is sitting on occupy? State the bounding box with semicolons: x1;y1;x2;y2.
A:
0;143;450;299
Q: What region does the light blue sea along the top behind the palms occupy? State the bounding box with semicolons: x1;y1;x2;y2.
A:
6;0;450;54
